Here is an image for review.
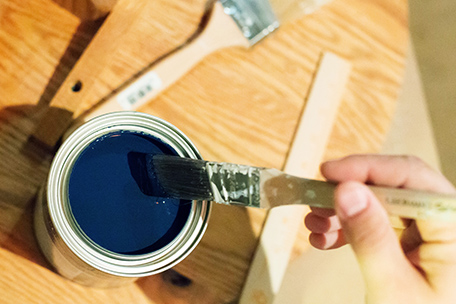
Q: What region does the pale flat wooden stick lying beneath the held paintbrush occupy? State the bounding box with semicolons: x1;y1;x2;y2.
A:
240;53;351;304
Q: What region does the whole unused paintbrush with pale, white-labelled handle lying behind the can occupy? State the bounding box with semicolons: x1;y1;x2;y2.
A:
81;0;331;121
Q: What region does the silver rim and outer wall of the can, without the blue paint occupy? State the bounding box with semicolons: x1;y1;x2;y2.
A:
34;112;211;287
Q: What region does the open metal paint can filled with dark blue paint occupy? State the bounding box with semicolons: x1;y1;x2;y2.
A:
35;112;210;287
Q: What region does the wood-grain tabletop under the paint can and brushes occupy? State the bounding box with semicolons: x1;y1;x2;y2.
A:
0;0;408;304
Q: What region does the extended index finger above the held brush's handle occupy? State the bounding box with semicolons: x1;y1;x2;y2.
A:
321;155;455;193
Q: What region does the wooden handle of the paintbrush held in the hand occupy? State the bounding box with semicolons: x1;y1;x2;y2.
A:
261;169;456;222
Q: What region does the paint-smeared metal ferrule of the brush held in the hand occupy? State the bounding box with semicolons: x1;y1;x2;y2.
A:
206;162;261;208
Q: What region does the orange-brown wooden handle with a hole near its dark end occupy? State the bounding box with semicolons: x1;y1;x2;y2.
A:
33;0;149;147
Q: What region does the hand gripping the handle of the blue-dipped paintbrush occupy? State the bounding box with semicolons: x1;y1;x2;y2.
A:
305;155;456;304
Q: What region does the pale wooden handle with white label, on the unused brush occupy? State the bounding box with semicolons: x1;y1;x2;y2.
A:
81;1;249;121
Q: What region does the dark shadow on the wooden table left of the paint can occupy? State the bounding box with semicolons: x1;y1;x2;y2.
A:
0;106;53;266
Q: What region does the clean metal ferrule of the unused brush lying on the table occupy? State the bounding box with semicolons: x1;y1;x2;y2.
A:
219;0;279;45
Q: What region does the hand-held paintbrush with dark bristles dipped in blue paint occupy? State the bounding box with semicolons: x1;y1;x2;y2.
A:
134;154;456;221
